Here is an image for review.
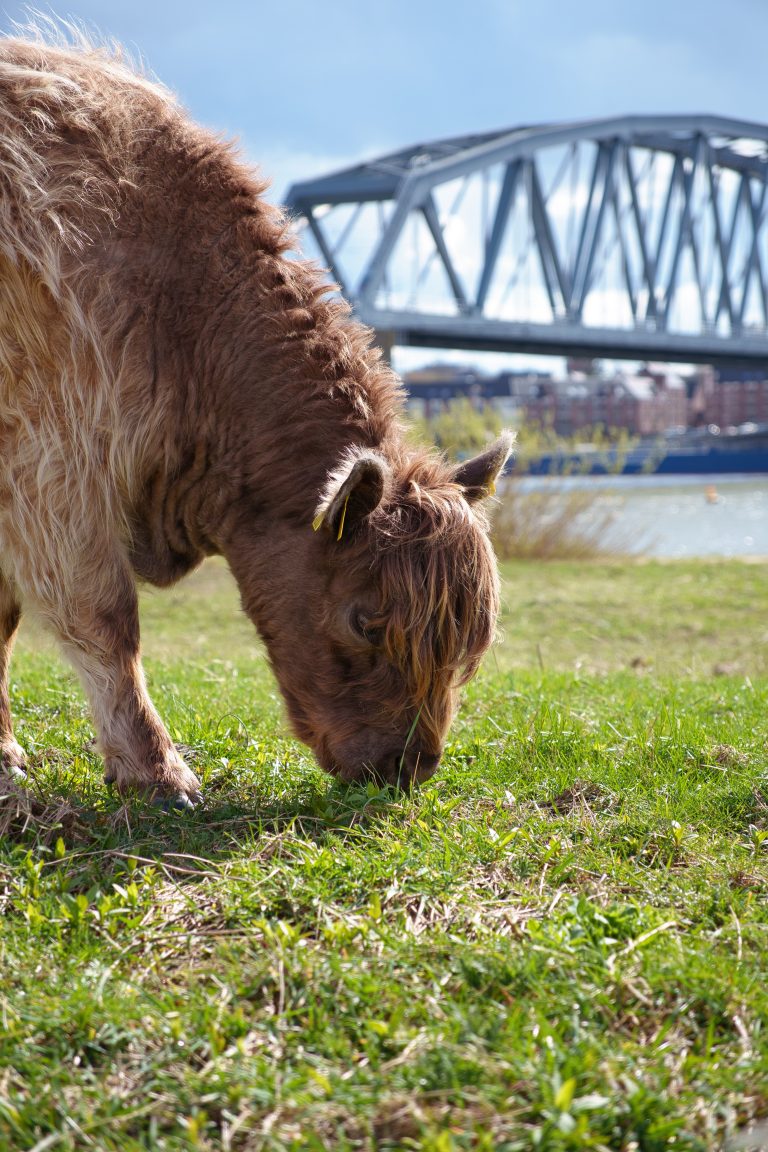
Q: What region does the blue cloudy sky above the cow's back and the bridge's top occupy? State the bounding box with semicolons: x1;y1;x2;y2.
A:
0;0;768;373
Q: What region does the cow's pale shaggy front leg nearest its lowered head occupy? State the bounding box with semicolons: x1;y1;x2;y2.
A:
41;545;199;806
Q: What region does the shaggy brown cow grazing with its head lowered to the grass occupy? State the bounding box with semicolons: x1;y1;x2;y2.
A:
0;29;511;803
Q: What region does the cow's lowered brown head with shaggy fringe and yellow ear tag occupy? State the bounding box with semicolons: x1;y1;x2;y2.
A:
231;433;512;785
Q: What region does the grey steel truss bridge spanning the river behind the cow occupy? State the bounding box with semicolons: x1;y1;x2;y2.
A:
288;115;768;366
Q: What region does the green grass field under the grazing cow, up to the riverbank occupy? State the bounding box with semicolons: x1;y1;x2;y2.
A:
0;562;768;1152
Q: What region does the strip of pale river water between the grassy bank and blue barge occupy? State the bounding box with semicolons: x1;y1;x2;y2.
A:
524;476;768;556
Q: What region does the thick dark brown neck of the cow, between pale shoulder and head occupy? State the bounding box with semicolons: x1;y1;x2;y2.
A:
119;172;402;583
